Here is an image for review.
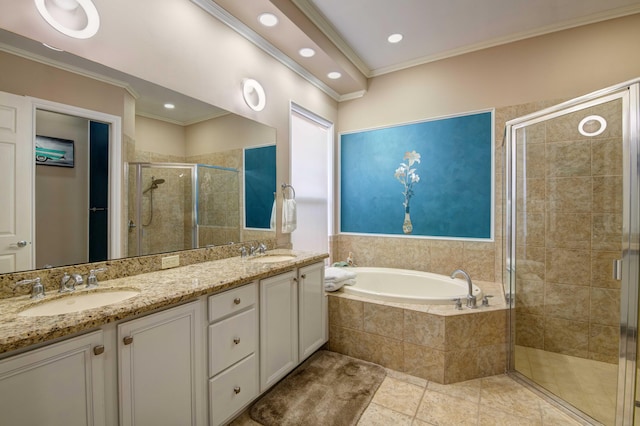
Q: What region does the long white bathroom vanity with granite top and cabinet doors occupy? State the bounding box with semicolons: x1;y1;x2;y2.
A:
0;252;328;426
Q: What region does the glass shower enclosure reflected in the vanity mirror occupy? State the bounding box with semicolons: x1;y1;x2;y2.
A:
127;163;240;256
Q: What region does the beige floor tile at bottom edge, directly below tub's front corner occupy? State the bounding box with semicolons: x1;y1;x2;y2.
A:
416;389;479;426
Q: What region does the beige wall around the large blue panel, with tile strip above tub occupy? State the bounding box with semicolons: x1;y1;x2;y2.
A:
332;14;640;282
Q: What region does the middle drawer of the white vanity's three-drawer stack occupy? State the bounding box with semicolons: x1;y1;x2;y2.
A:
209;308;258;377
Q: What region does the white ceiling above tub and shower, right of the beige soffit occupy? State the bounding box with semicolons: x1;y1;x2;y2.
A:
293;0;640;76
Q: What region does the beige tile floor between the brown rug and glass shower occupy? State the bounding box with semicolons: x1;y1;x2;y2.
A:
232;370;586;426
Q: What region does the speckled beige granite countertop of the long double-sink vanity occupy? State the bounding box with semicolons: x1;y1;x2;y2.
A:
0;250;328;357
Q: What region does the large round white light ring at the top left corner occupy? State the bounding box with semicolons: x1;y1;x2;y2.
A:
34;0;100;39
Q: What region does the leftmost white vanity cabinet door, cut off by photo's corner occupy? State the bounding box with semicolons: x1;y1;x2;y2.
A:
0;331;105;426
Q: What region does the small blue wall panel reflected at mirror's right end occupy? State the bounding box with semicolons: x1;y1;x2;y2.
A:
244;145;276;229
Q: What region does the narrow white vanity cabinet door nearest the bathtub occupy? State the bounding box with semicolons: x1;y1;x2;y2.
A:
298;263;327;361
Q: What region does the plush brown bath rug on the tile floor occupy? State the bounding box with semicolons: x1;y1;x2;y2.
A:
249;351;386;426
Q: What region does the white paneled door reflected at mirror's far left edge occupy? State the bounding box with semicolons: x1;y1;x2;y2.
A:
0;92;34;273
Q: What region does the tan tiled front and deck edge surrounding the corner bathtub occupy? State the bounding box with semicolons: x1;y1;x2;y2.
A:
329;281;507;384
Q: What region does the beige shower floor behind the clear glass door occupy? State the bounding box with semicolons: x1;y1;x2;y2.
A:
516;346;618;426
